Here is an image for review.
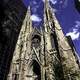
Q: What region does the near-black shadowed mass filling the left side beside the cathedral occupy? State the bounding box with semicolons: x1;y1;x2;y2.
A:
0;0;27;80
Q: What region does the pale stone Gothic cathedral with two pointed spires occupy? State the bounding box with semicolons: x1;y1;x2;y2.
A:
7;0;80;80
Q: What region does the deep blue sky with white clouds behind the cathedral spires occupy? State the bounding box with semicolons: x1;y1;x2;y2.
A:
23;0;80;56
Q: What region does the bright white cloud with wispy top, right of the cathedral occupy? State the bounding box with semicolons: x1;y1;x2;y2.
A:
66;21;80;40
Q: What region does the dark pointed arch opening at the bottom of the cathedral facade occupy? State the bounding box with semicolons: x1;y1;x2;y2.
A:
26;60;41;80
